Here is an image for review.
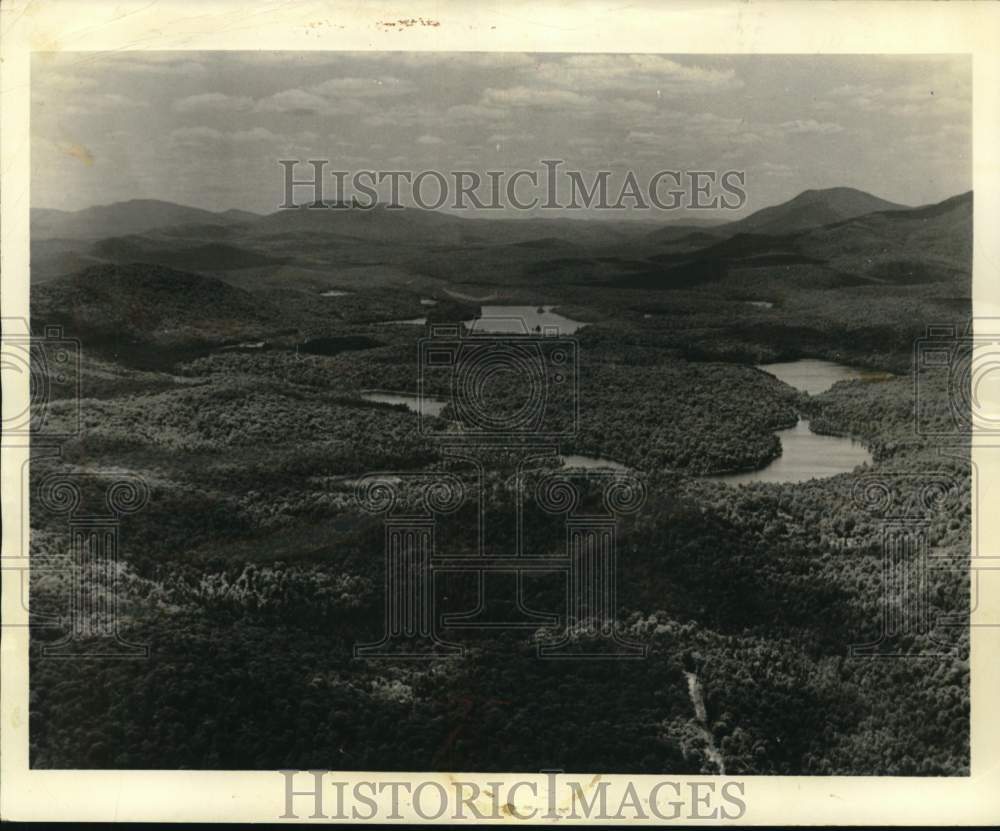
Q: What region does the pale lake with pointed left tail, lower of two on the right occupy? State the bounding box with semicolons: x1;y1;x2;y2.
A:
706;419;872;485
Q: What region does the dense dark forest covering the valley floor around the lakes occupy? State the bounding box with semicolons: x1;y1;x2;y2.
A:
31;192;972;775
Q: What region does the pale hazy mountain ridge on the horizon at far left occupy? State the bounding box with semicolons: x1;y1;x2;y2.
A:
31;199;260;240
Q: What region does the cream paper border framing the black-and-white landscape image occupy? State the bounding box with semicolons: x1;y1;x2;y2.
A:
0;0;1000;825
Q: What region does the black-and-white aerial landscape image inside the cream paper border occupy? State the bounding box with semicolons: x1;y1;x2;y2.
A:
3;0;1000;822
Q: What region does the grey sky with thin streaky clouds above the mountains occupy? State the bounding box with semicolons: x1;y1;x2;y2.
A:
31;52;972;220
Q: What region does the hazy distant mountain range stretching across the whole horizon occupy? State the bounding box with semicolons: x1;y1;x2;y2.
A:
31;188;972;296
